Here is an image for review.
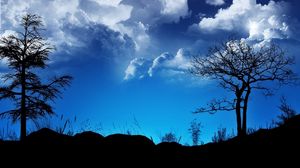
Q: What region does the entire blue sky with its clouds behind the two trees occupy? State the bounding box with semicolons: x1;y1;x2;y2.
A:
0;0;300;143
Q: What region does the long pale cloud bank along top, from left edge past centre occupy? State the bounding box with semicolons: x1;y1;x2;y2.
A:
0;0;188;56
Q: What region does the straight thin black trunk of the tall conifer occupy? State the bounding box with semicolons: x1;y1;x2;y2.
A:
20;65;26;141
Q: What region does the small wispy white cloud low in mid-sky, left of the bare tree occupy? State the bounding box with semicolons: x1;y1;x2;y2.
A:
123;48;210;87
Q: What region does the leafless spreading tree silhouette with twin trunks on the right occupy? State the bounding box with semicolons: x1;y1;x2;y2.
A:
191;40;296;136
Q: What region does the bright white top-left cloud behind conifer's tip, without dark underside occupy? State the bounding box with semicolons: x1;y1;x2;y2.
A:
0;0;132;49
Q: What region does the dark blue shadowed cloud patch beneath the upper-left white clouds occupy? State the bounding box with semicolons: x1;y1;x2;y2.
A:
63;24;135;61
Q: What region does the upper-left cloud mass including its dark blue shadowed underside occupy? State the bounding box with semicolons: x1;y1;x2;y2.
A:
0;0;136;61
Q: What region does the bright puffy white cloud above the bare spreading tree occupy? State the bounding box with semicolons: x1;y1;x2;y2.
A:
199;0;290;40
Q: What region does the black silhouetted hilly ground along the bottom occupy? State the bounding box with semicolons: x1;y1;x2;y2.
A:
0;116;300;164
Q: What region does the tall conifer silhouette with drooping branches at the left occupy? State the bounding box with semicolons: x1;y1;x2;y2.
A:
0;14;72;141
